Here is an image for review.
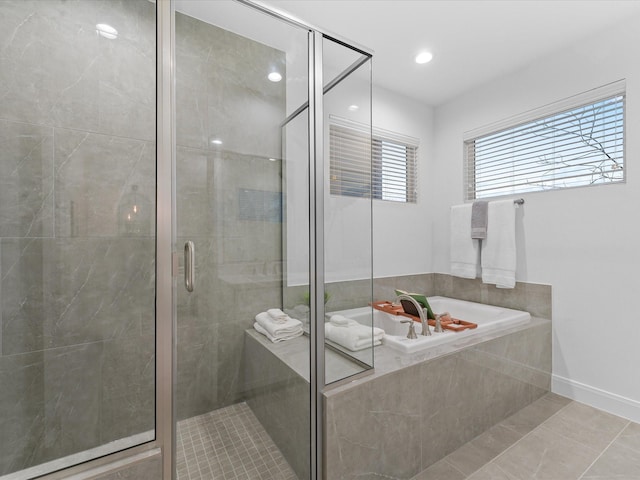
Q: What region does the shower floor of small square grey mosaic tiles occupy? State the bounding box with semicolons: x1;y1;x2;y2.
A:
176;402;297;480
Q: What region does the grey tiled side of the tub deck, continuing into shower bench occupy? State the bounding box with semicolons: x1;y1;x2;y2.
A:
245;302;551;479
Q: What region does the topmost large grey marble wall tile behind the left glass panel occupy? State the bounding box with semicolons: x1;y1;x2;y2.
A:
0;0;155;140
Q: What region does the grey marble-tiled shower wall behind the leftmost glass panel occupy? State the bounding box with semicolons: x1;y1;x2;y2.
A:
0;0;155;475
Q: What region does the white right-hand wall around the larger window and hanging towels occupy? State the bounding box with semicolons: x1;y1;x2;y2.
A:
432;14;640;421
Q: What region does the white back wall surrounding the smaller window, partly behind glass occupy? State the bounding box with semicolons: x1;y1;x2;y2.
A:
285;72;433;285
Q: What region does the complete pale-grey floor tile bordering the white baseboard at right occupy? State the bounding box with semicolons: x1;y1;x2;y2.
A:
543;402;628;451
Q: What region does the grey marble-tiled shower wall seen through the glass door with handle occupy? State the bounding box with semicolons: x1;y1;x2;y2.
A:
176;13;285;419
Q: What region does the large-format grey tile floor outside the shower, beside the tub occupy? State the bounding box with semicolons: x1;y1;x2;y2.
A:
413;393;640;480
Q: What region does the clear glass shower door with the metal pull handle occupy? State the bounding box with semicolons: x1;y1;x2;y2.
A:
175;1;310;479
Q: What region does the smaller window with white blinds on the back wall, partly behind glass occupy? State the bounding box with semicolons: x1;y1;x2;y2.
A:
329;124;418;203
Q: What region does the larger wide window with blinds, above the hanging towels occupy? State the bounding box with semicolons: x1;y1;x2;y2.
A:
465;82;625;200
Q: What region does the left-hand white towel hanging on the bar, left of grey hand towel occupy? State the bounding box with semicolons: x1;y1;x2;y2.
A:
450;205;479;278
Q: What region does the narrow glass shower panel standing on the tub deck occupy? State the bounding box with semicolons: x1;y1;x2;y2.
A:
323;38;372;383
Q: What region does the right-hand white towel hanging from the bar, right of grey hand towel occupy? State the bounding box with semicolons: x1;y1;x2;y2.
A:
481;200;516;288
